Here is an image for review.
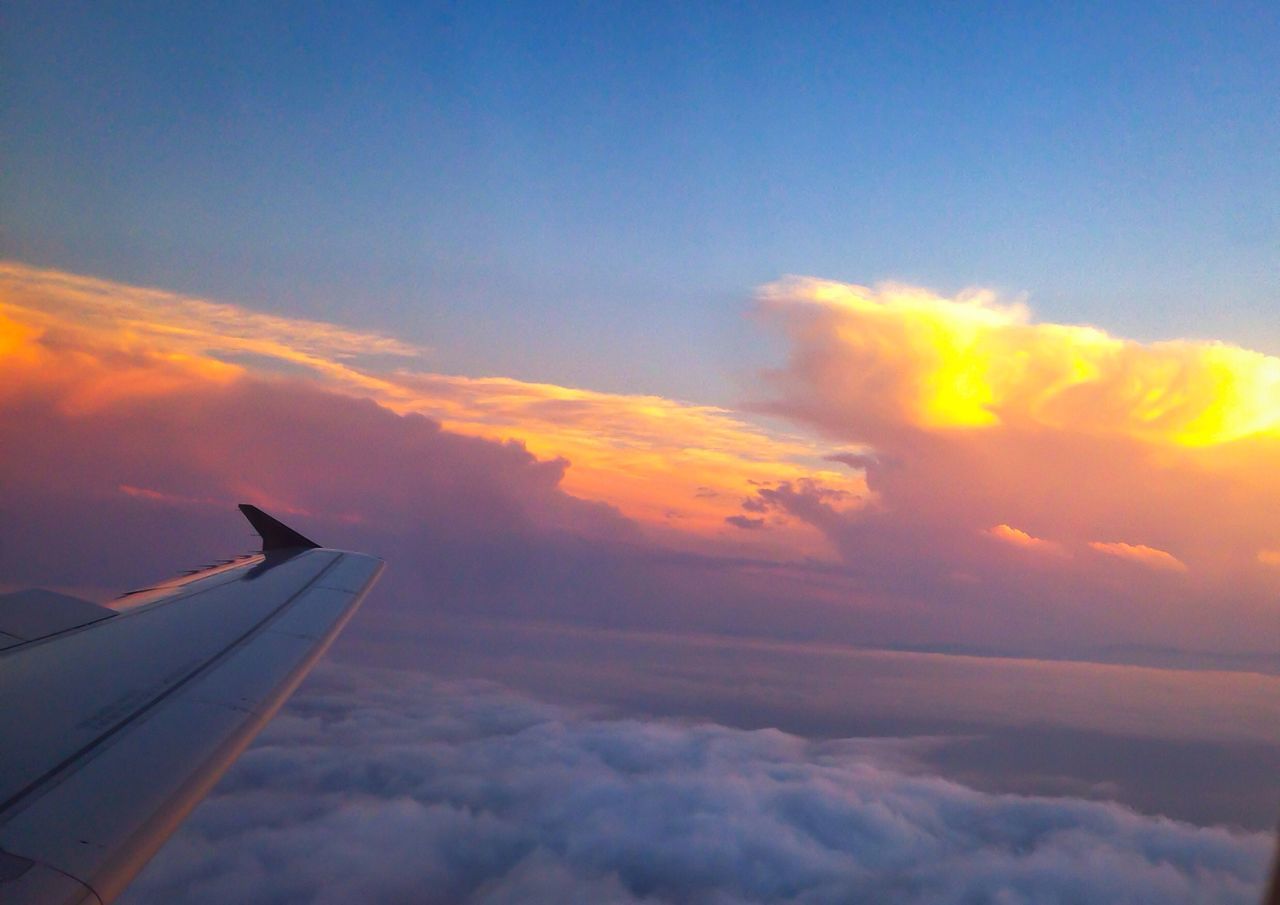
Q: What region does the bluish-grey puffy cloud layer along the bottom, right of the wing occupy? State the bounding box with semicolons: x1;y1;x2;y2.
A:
123;666;1270;905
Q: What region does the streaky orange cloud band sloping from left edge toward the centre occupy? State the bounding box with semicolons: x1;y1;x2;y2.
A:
0;262;868;556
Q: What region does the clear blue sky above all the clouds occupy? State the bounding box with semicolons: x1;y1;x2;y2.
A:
0;3;1280;401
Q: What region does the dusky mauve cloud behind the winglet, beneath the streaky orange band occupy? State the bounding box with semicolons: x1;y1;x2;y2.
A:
0;335;636;599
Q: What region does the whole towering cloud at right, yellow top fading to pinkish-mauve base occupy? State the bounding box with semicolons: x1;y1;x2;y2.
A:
759;278;1280;650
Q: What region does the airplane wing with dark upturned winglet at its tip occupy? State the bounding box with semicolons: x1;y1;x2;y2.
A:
0;506;383;905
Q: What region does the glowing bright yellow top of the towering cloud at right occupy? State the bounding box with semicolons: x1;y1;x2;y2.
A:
760;278;1280;447
